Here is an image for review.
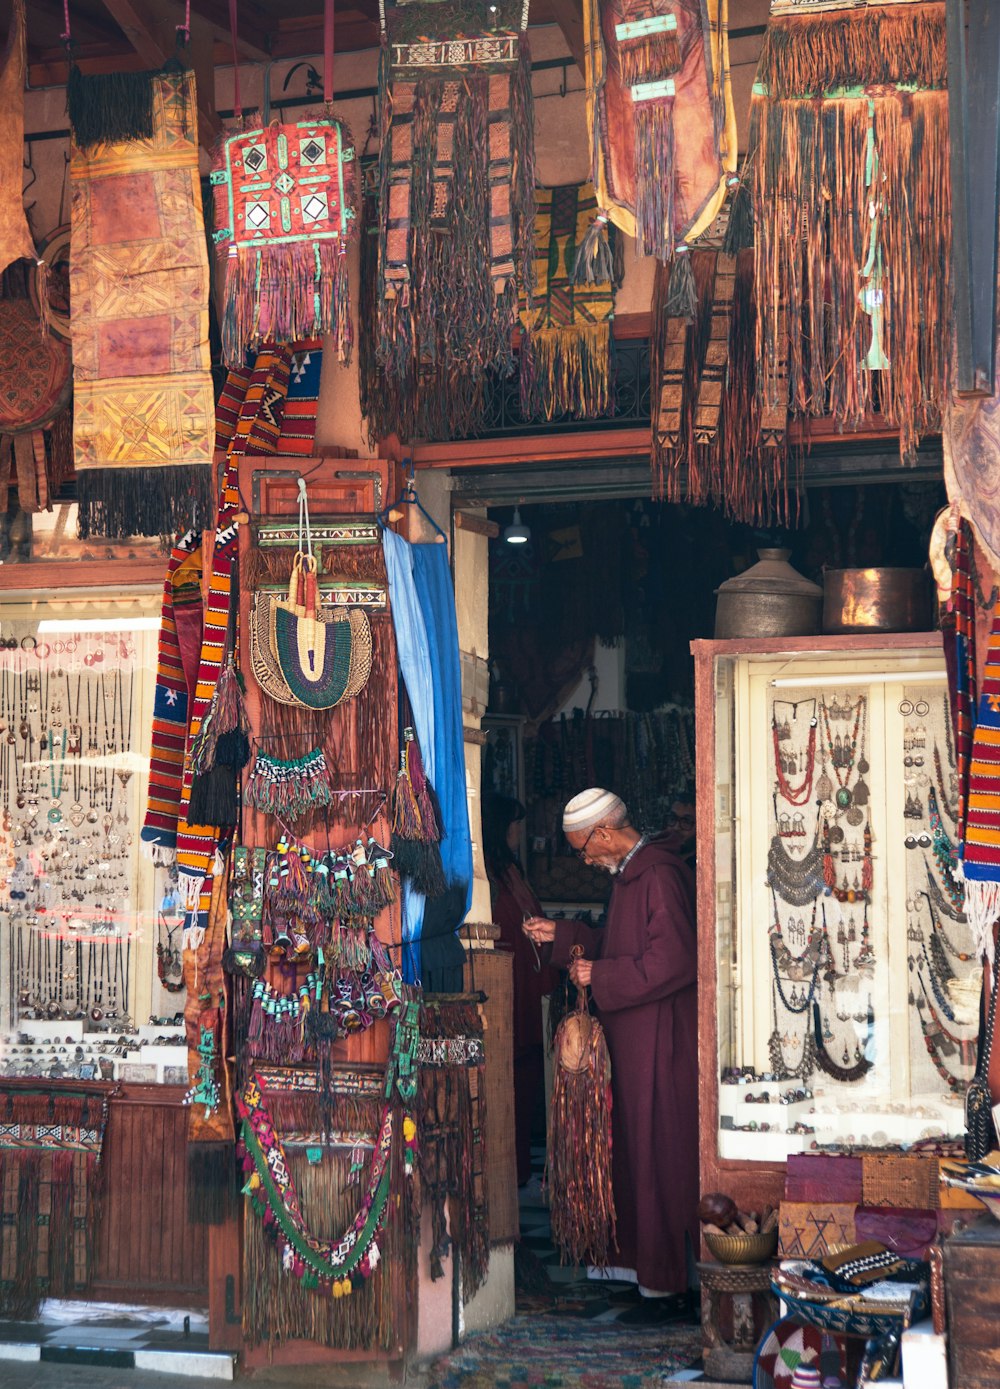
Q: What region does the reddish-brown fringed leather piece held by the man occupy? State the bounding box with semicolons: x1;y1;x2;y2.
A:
546;1013;617;1268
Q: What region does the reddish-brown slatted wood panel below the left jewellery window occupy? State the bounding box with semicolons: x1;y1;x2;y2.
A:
90;1086;208;1306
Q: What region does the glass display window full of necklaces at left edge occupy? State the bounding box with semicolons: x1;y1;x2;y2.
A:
0;592;186;1085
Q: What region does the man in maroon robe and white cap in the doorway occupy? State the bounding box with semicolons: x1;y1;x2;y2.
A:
524;788;699;1318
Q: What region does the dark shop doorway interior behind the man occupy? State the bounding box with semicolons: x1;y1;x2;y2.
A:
482;479;944;1314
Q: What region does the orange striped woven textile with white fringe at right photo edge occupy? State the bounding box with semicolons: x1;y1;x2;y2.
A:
963;588;1000;965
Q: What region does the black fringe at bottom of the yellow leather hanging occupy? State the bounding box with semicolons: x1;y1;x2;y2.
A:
76;464;215;540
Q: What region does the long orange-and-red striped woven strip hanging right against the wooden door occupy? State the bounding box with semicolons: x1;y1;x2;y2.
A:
176;454;242;908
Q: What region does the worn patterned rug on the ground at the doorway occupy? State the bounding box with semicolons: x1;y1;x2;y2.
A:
426;1317;701;1389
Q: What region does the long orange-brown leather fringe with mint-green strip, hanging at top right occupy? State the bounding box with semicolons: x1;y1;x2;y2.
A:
750;92;951;461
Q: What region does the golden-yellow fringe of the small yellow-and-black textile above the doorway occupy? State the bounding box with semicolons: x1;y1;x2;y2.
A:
521;322;611;419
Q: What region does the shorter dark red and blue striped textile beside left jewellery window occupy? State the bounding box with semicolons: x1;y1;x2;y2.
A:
139;531;201;864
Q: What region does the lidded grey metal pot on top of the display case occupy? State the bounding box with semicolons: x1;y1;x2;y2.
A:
715;550;824;639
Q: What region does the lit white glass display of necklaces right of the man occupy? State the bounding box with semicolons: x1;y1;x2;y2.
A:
700;636;982;1161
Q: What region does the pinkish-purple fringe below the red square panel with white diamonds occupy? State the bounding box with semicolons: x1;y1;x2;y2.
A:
222;242;353;367
